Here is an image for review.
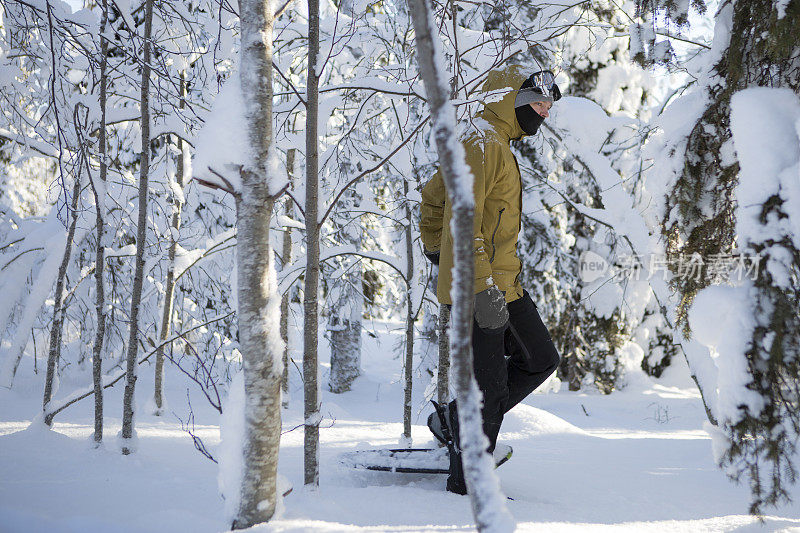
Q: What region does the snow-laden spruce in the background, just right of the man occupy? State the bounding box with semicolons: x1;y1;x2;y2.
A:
548;1;671;392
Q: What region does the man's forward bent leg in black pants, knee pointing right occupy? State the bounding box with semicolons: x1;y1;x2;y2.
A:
503;291;561;414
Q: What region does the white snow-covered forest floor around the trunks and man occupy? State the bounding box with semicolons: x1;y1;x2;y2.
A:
0;324;800;533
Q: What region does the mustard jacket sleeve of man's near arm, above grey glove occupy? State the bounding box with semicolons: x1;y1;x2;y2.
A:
464;140;497;294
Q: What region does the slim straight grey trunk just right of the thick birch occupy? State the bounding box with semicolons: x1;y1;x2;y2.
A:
303;0;320;487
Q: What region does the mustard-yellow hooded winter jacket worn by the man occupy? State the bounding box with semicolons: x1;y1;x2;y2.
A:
420;65;525;304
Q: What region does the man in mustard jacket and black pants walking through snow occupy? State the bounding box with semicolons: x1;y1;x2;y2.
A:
420;66;561;494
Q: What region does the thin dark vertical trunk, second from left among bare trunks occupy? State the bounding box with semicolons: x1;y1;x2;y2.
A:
89;0;108;443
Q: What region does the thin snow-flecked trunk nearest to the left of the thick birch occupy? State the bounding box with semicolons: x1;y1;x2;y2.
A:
153;72;189;416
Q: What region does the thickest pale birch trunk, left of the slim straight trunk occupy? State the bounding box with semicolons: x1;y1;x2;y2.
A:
232;0;285;529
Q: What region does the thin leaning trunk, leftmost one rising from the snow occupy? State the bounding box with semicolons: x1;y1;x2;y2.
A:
42;169;81;426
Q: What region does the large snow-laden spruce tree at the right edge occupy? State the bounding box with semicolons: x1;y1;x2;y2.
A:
642;0;800;513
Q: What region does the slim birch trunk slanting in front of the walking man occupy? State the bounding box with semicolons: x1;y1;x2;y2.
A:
409;0;514;531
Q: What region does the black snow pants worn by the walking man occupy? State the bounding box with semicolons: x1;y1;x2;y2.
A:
472;291;561;452
